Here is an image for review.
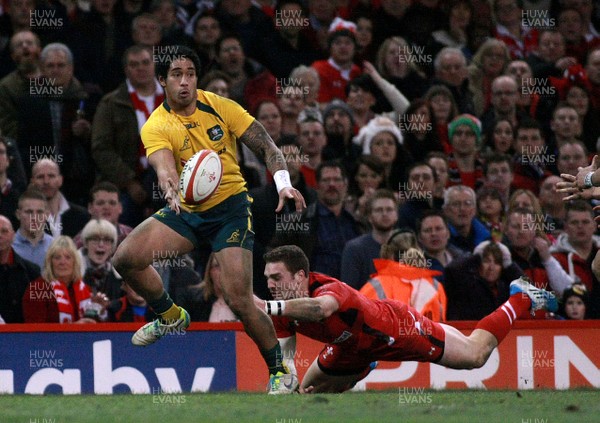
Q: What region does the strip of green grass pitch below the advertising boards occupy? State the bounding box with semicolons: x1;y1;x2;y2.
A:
0;388;600;423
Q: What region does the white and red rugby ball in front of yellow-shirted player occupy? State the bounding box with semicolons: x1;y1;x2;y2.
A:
179;150;223;204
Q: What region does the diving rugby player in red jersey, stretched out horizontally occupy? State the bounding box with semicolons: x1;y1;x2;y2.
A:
255;245;557;393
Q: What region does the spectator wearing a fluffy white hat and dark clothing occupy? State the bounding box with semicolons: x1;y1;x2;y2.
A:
353;116;412;190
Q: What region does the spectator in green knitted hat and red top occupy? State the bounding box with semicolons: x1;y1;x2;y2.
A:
448;114;483;189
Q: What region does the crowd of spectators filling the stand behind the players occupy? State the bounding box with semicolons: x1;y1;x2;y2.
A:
0;0;600;323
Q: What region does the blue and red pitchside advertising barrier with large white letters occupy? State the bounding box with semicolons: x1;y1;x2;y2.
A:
0;320;600;398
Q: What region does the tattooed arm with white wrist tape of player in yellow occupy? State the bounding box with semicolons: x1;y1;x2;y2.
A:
240;120;306;213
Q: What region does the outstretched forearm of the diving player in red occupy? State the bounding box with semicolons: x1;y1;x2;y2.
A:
265;295;340;322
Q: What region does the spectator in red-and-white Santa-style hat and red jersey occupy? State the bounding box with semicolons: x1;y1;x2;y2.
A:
312;18;361;103
